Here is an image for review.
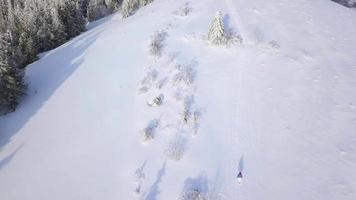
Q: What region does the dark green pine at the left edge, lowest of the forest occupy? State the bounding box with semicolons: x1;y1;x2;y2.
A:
0;32;26;114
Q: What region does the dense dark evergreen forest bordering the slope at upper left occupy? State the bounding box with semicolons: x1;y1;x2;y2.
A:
0;0;122;115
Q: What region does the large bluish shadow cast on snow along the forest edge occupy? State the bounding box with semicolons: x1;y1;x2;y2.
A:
0;27;104;152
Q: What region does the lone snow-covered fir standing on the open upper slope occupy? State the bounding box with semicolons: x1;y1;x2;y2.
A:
208;12;226;45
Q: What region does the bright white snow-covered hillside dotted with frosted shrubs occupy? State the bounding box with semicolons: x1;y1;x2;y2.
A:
0;0;356;200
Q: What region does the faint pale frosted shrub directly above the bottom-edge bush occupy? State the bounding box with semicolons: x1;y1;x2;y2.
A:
166;135;187;161
